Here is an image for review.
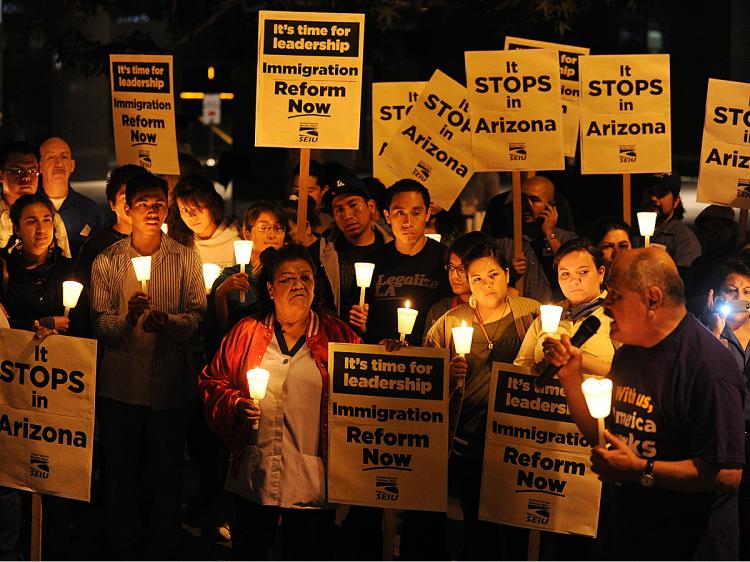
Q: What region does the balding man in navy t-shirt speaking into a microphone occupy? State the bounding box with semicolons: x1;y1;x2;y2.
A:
548;247;745;560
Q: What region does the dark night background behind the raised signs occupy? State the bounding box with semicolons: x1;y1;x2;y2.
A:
0;0;750;225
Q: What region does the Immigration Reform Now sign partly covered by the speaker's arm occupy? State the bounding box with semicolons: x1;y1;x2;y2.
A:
479;363;601;537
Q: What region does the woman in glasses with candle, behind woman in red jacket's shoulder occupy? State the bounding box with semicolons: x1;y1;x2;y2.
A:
207;201;289;352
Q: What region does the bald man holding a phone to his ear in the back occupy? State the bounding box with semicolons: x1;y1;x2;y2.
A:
498;176;577;303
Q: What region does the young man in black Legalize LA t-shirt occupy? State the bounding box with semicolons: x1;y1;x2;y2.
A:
350;179;452;345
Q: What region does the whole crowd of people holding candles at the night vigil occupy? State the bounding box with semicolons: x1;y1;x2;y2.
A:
0;138;750;559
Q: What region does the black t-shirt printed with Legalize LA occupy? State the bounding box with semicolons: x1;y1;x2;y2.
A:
365;238;451;345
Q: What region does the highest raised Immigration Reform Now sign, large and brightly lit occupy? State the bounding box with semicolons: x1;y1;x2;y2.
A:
255;10;365;149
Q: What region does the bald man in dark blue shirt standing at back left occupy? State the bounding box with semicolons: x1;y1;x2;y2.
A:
39;137;104;259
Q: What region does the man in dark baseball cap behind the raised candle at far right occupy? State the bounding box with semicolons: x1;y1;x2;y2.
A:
643;171;701;268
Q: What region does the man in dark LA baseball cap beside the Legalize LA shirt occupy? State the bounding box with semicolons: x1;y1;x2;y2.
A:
309;176;393;319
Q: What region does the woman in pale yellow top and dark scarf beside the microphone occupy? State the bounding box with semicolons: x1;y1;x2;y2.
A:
515;238;615;377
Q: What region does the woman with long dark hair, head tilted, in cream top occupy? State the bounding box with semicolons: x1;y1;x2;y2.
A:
167;175;240;267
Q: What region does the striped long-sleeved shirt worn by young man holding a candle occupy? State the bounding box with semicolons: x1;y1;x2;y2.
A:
91;236;206;411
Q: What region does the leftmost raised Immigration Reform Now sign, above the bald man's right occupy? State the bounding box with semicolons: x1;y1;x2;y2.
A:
109;55;180;175
